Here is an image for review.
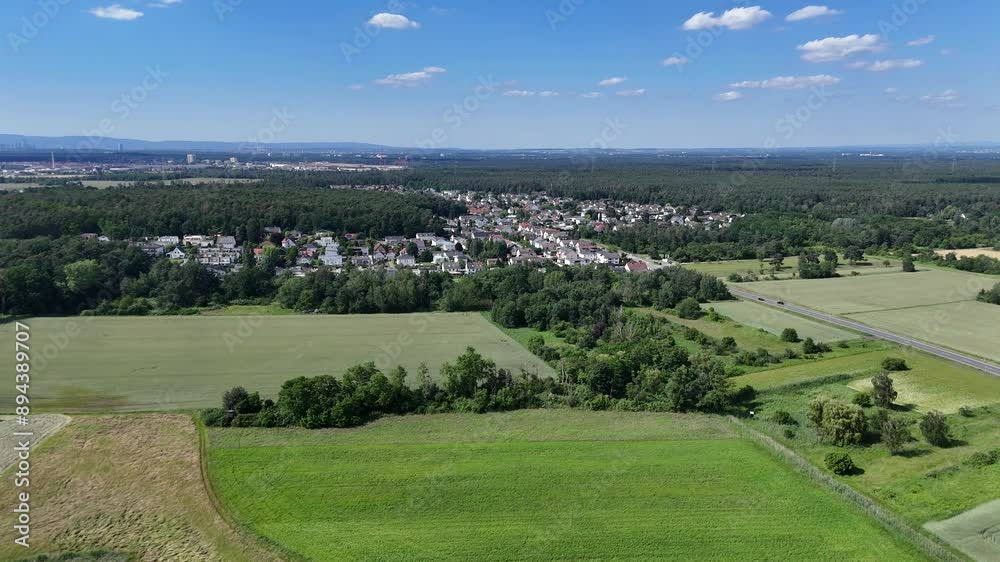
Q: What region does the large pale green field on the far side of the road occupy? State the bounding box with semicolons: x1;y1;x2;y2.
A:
739;266;1000;361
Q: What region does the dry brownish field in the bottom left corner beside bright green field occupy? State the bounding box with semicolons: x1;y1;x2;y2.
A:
0;415;274;562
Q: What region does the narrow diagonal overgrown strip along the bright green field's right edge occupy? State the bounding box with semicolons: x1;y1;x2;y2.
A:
726;416;965;562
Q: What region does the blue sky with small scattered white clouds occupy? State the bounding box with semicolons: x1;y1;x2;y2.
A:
0;0;1000;148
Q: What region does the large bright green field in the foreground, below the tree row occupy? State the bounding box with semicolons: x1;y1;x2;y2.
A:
208;410;921;560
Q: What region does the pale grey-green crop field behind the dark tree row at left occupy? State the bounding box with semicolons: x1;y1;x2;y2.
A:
0;313;552;412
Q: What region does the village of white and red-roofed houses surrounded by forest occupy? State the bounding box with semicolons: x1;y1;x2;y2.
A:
97;186;741;277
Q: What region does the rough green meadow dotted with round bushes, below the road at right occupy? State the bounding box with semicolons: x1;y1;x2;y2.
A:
752;350;1000;548
